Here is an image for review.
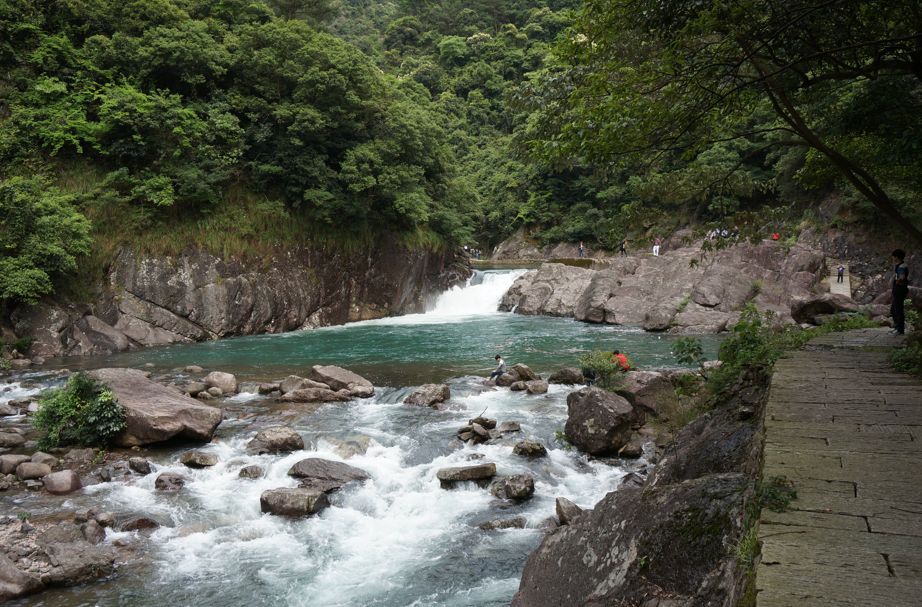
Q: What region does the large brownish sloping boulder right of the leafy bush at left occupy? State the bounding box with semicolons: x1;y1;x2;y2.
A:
90;369;224;447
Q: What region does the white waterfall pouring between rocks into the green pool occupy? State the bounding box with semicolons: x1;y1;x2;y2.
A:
353;270;527;325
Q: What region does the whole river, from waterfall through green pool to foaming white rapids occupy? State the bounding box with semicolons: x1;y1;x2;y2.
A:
0;270;718;607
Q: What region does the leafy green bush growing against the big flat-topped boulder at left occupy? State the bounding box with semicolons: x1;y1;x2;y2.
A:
33;373;126;449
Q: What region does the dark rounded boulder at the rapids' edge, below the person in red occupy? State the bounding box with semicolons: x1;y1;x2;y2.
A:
564;387;637;455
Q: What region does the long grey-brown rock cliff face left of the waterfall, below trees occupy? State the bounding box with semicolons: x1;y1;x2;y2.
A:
12;245;468;357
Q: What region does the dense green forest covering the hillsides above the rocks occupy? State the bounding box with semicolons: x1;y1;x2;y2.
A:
0;0;922;301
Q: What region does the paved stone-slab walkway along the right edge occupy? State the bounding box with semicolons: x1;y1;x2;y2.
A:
756;329;922;607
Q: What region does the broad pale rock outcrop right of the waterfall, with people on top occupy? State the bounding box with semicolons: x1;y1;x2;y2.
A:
500;241;825;333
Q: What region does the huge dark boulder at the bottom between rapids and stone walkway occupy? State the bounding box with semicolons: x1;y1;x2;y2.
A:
512;474;750;607
